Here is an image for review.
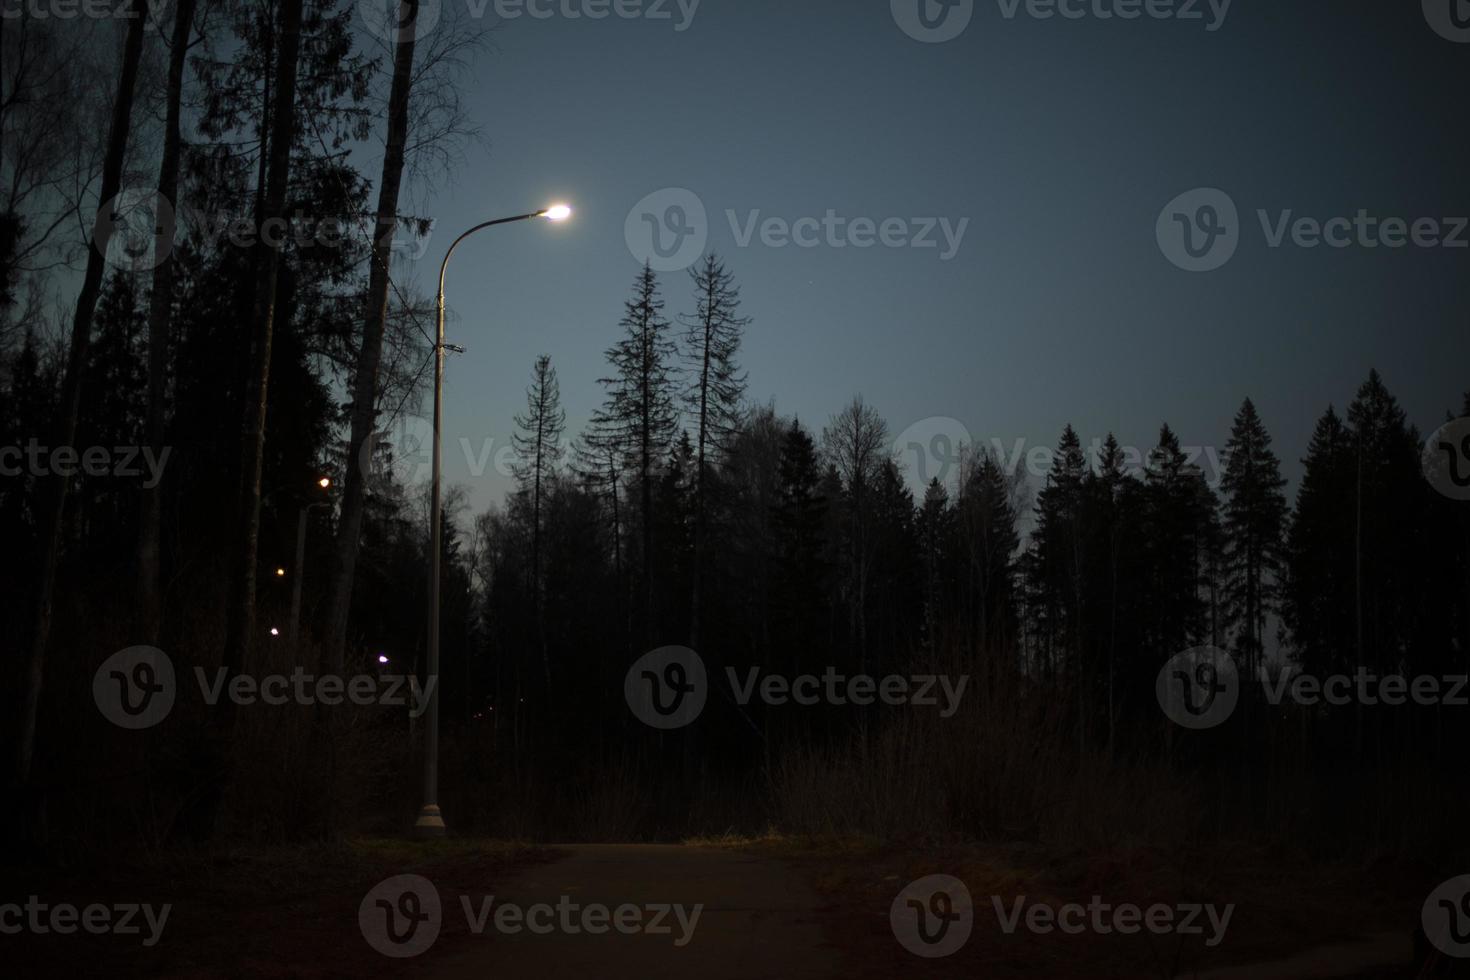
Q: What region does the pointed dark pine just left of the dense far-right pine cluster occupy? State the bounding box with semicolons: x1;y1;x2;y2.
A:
1222;398;1286;677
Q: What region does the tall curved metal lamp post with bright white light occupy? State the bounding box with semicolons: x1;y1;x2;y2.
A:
413;204;572;837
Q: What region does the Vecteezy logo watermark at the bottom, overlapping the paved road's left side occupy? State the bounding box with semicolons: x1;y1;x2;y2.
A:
357;874;704;959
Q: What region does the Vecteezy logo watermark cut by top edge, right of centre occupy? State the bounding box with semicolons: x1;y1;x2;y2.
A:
889;0;1232;44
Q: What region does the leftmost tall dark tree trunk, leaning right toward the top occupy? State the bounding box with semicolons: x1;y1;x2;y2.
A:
15;0;144;786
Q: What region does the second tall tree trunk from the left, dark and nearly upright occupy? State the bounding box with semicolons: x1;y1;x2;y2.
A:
138;0;194;644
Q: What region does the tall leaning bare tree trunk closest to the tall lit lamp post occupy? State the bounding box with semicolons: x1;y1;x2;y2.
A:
325;0;419;673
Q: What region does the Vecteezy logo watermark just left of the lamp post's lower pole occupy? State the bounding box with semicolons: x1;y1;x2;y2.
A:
93;646;440;730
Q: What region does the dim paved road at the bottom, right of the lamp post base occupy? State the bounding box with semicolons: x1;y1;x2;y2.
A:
431;845;838;980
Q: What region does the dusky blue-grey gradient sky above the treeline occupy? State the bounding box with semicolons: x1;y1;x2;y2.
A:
369;0;1470;511
